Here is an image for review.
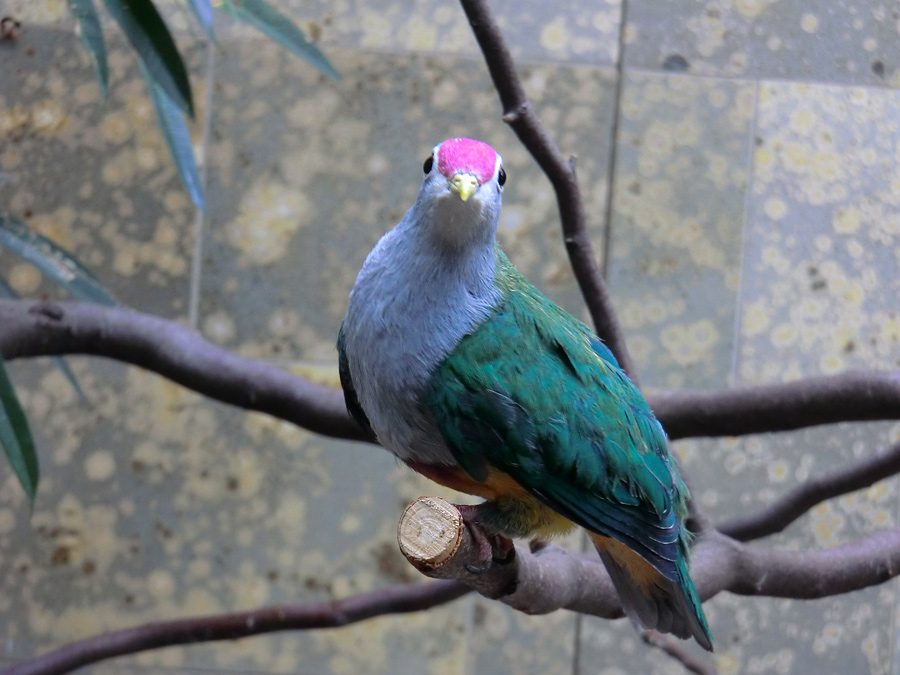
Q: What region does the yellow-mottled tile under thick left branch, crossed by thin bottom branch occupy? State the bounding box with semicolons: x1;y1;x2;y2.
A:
0;359;468;674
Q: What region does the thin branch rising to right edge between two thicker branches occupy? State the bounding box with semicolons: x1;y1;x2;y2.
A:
716;443;900;541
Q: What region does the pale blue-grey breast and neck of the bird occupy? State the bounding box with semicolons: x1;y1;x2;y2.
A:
344;221;499;464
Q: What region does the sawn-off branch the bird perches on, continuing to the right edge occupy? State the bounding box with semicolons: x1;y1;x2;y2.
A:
401;498;900;619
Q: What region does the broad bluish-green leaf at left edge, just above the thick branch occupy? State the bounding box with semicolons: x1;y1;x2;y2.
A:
0;214;119;307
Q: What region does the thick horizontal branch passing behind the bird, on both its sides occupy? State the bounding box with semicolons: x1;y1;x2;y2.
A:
0;300;900;440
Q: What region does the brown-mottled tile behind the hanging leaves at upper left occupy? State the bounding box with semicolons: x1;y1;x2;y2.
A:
0;25;203;317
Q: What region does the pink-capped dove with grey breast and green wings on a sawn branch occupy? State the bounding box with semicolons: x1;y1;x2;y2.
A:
337;138;713;651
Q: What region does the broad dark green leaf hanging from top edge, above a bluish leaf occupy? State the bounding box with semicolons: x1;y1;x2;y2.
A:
105;0;194;118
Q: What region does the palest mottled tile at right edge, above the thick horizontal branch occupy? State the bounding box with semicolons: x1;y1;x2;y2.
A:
739;83;900;383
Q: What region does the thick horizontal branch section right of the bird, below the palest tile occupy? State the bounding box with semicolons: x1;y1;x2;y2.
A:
647;371;900;439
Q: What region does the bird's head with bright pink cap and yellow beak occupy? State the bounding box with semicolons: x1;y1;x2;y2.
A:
416;138;506;248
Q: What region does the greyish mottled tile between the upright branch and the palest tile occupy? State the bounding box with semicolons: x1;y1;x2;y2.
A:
607;72;756;387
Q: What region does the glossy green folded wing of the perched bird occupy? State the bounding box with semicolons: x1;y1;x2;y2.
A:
426;251;687;579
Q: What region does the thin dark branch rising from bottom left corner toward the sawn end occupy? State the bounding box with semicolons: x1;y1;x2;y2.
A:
0;581;469;675
